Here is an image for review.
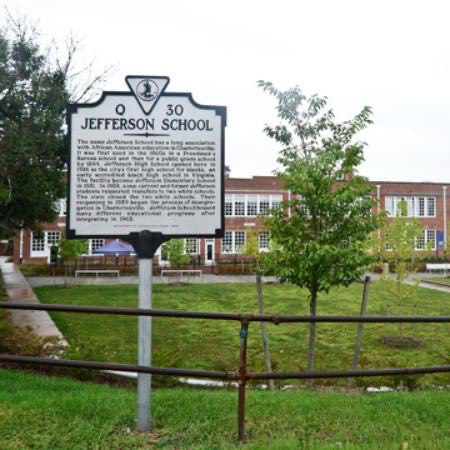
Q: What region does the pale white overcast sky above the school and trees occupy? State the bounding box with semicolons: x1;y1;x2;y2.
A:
6;0;450;182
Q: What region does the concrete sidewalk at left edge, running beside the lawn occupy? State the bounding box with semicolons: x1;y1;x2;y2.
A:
0;257;68;345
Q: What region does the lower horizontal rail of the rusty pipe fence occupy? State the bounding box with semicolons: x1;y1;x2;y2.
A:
0;355;450;380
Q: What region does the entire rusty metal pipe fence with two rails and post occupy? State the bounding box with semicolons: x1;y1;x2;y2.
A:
0;302;450;441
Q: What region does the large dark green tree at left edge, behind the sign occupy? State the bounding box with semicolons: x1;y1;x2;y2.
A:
0;17;104;238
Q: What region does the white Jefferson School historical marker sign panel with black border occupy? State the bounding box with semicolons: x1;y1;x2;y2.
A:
67;76;226;238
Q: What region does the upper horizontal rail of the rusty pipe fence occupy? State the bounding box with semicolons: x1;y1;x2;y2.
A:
0;302;450;324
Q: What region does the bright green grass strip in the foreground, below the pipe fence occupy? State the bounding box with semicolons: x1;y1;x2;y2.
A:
0;370;450;450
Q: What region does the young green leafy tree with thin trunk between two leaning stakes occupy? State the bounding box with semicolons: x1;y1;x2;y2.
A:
258;81;380;385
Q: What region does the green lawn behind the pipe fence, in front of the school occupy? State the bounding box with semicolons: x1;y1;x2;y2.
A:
36;283;450;387
